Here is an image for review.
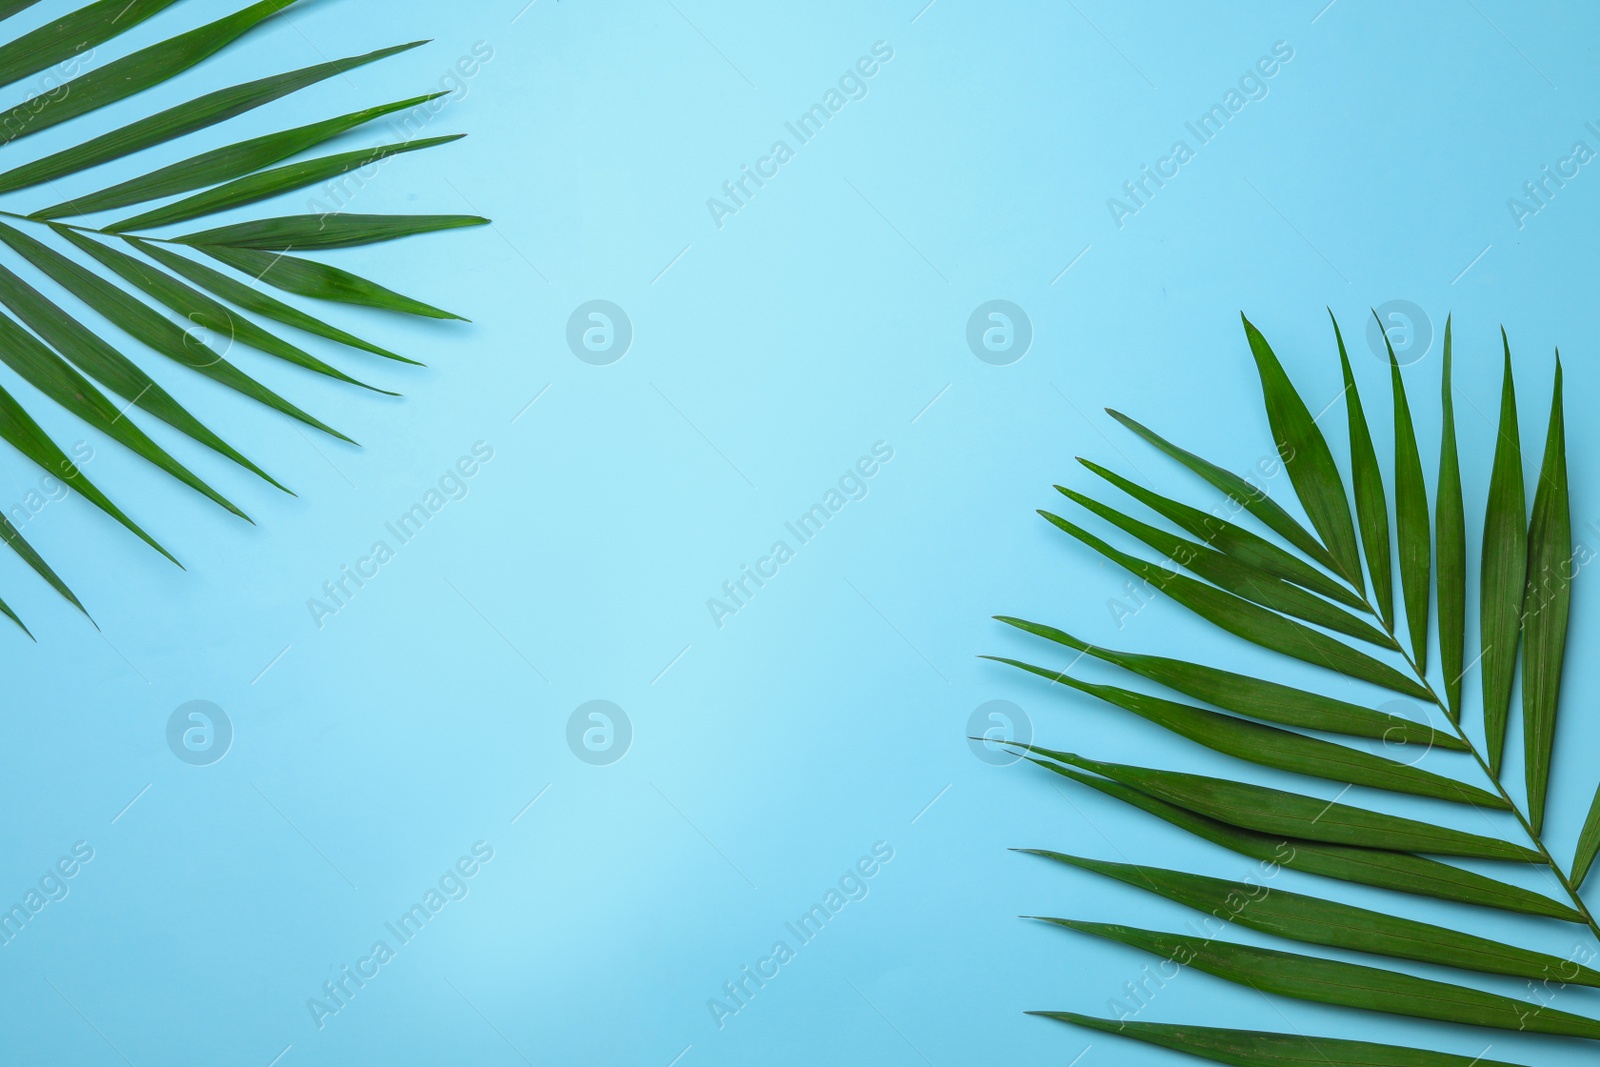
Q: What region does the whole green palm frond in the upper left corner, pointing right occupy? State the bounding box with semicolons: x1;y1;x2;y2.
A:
0;0;485;633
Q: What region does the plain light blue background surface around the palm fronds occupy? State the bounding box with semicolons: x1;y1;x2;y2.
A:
0;0;1600;1067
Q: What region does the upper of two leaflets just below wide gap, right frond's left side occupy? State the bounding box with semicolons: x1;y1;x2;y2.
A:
995;616;1467;752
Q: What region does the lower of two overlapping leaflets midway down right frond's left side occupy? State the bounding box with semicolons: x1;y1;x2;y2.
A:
1034;760;1584;926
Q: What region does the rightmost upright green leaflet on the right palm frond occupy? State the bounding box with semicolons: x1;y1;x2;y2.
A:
1522;352;1574;833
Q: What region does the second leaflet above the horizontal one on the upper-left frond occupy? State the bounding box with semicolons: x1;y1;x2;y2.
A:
39;92;445;219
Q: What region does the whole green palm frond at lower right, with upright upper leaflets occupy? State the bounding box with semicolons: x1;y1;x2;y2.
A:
989;313;1600;1067
